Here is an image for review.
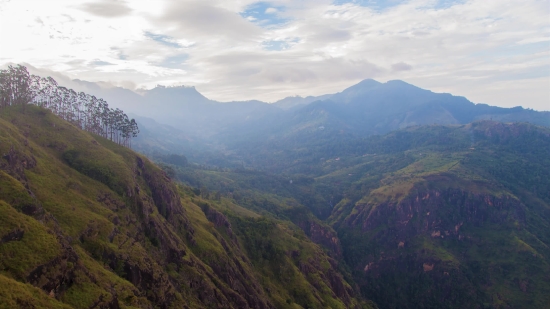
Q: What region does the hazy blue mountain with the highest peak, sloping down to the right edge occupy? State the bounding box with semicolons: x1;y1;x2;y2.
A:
219;79;550;151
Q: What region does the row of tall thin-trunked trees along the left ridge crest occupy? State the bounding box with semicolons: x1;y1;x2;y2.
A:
0;65;139;147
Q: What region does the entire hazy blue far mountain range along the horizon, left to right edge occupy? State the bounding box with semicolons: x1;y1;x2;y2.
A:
49;73;550;159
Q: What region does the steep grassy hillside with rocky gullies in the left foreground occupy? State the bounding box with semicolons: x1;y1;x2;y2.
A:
0;105;376;308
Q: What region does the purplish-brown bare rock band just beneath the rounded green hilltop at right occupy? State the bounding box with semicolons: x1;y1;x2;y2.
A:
347;179;525;241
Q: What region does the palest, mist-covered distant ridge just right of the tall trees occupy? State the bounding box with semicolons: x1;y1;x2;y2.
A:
56;81;282;138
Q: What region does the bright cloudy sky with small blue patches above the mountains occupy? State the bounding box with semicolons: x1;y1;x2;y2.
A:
0;0;550;110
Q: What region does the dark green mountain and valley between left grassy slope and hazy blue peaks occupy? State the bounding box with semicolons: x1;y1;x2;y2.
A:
165;121;550;308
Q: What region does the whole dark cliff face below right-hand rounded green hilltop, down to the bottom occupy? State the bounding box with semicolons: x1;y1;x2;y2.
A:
338;174;550;308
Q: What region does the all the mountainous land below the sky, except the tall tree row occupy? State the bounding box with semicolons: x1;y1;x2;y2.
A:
0;70;550;309
